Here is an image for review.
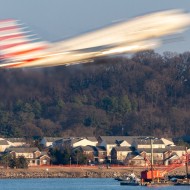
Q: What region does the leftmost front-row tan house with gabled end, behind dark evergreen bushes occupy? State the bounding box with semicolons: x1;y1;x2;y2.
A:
6;147;50;166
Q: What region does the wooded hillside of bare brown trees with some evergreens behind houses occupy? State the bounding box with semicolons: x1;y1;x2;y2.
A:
0;51;190;137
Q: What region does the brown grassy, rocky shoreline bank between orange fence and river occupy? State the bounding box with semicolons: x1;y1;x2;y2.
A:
0;167;188;179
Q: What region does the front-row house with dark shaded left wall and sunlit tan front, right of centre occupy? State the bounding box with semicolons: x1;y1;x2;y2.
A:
111;146;132;164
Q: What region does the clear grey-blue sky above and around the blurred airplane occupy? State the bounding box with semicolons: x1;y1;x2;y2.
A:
0;0;190;53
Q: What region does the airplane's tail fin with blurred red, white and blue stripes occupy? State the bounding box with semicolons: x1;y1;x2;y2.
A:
0;19;48;63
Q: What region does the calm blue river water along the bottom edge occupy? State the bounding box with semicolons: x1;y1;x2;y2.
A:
0;178;190;190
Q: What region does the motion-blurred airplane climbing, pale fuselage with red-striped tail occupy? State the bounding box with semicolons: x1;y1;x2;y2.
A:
0;10;190;68
